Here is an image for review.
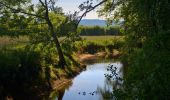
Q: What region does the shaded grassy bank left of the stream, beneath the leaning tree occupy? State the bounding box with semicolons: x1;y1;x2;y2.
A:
0;47;85;100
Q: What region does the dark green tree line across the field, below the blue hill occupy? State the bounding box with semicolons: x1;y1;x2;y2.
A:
78;26;121;36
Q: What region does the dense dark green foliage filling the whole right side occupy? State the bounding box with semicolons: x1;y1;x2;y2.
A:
99;0;170;100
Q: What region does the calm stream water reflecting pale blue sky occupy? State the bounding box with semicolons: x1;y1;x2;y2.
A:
54;62;123;100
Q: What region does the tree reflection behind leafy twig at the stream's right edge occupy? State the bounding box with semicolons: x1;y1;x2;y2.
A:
97;65;123;100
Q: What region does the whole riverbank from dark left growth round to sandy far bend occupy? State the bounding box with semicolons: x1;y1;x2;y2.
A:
0;37;121;99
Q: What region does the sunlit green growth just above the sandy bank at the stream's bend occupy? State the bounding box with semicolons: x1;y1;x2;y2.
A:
74;36;124;54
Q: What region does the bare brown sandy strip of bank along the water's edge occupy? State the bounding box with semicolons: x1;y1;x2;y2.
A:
53;50;121;90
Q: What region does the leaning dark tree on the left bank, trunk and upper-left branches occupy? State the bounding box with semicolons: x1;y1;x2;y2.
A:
0;0;66;68
